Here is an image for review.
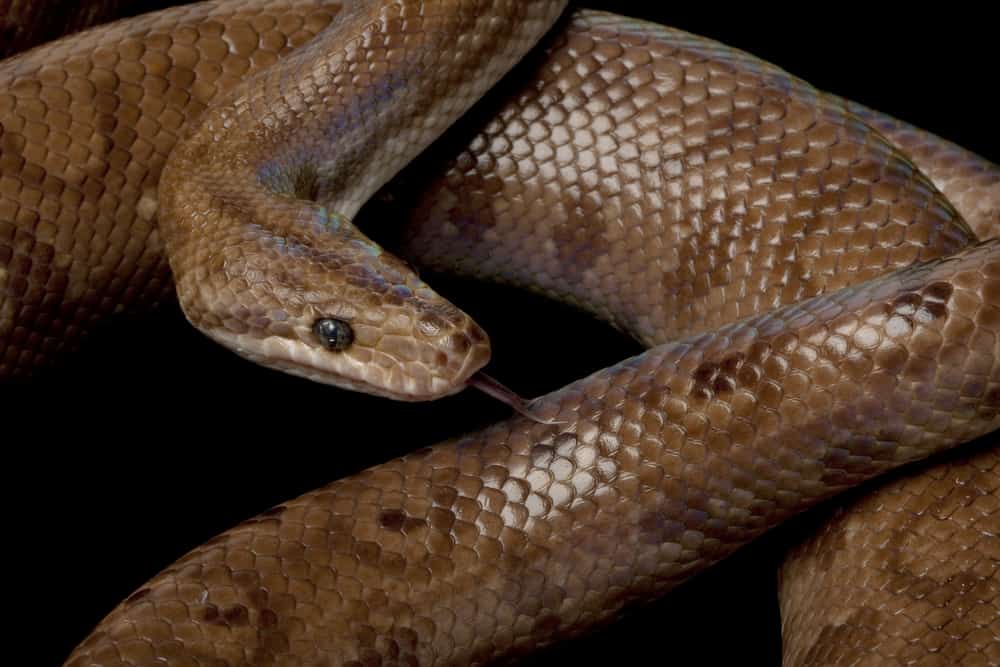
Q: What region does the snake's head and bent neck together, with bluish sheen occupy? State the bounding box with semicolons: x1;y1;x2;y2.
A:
160;0;565;400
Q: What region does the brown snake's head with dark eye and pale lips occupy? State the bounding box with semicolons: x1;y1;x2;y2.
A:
170;202;490;401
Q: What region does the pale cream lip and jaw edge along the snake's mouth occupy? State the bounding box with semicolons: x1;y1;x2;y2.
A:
206;331;490;402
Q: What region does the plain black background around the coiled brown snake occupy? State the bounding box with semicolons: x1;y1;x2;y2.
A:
0;1;1000;665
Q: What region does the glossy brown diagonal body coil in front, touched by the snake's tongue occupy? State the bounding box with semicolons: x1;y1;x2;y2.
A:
67;241;1000;667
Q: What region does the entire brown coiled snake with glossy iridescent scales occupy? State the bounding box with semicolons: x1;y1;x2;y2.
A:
0;2;998;665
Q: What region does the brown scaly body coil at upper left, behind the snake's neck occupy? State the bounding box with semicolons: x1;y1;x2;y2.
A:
0;2;340;375
